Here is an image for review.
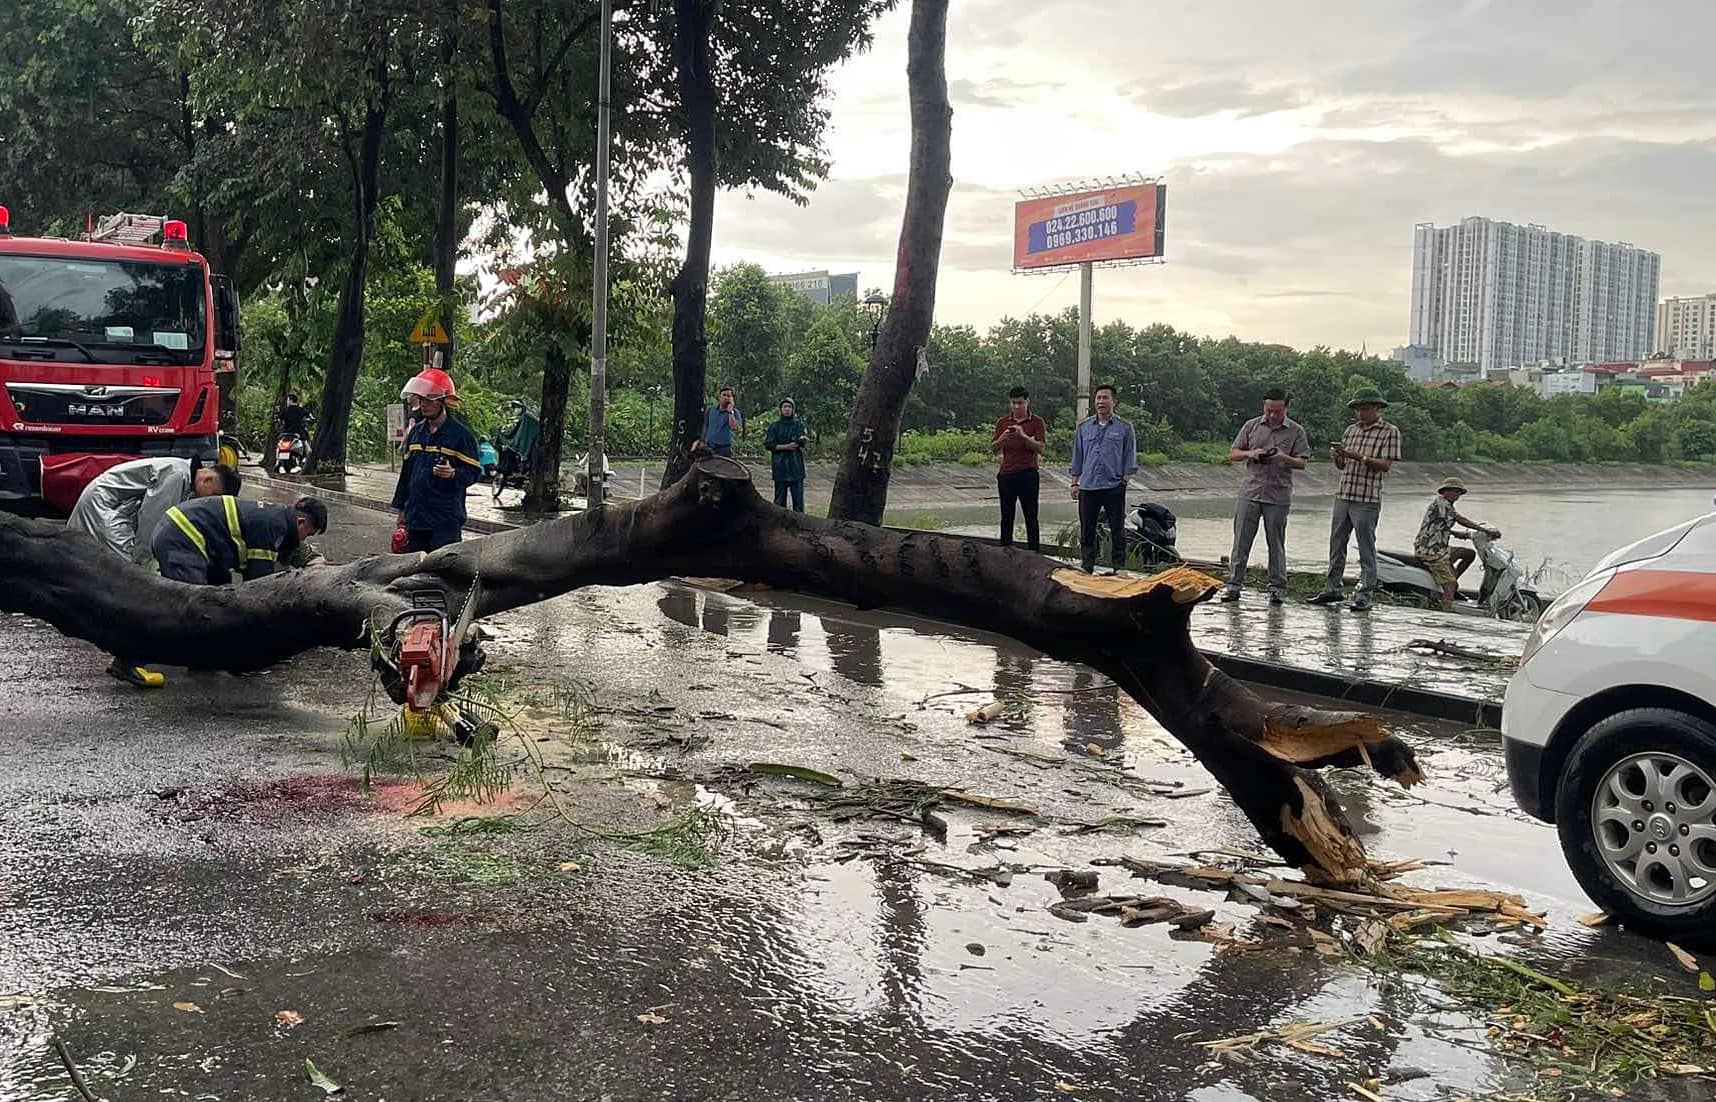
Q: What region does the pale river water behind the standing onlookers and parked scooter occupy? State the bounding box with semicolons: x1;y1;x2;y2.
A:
940;486;1713;592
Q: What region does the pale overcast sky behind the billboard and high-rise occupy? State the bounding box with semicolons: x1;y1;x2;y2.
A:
716;0;1716;352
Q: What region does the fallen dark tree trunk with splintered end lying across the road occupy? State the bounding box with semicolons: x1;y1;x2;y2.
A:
0;457;1417;881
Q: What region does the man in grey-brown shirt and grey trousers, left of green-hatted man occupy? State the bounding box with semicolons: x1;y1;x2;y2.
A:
1222;386;1311;604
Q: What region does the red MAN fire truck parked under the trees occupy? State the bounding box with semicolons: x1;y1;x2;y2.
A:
0;206;239;512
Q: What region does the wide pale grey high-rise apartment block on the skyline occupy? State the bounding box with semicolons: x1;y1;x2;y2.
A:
1411;218;1663;369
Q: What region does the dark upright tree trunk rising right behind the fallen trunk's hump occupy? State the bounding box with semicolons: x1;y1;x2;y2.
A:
661;0;716;487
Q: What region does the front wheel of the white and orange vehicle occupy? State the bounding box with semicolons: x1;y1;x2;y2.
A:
1555;707;1716;948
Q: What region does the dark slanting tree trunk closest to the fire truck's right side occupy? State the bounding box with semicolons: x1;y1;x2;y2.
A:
307;97;388;474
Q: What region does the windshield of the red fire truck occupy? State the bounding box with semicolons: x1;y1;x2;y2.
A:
0;254;204;364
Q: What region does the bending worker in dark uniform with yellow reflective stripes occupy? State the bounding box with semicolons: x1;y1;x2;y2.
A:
153;496;328;585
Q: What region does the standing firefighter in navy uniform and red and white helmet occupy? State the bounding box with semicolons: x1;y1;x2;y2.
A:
393;367;482;551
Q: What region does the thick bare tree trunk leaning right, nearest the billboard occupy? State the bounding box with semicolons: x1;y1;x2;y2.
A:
829;0;954;524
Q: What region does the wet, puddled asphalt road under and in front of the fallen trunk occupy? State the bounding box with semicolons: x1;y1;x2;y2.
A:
0;512;1707;1102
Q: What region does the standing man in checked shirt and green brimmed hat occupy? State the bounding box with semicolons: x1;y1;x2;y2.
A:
1311;386;1400;613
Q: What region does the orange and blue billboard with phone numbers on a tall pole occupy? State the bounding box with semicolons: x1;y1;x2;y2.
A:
1012;184;1169;271
